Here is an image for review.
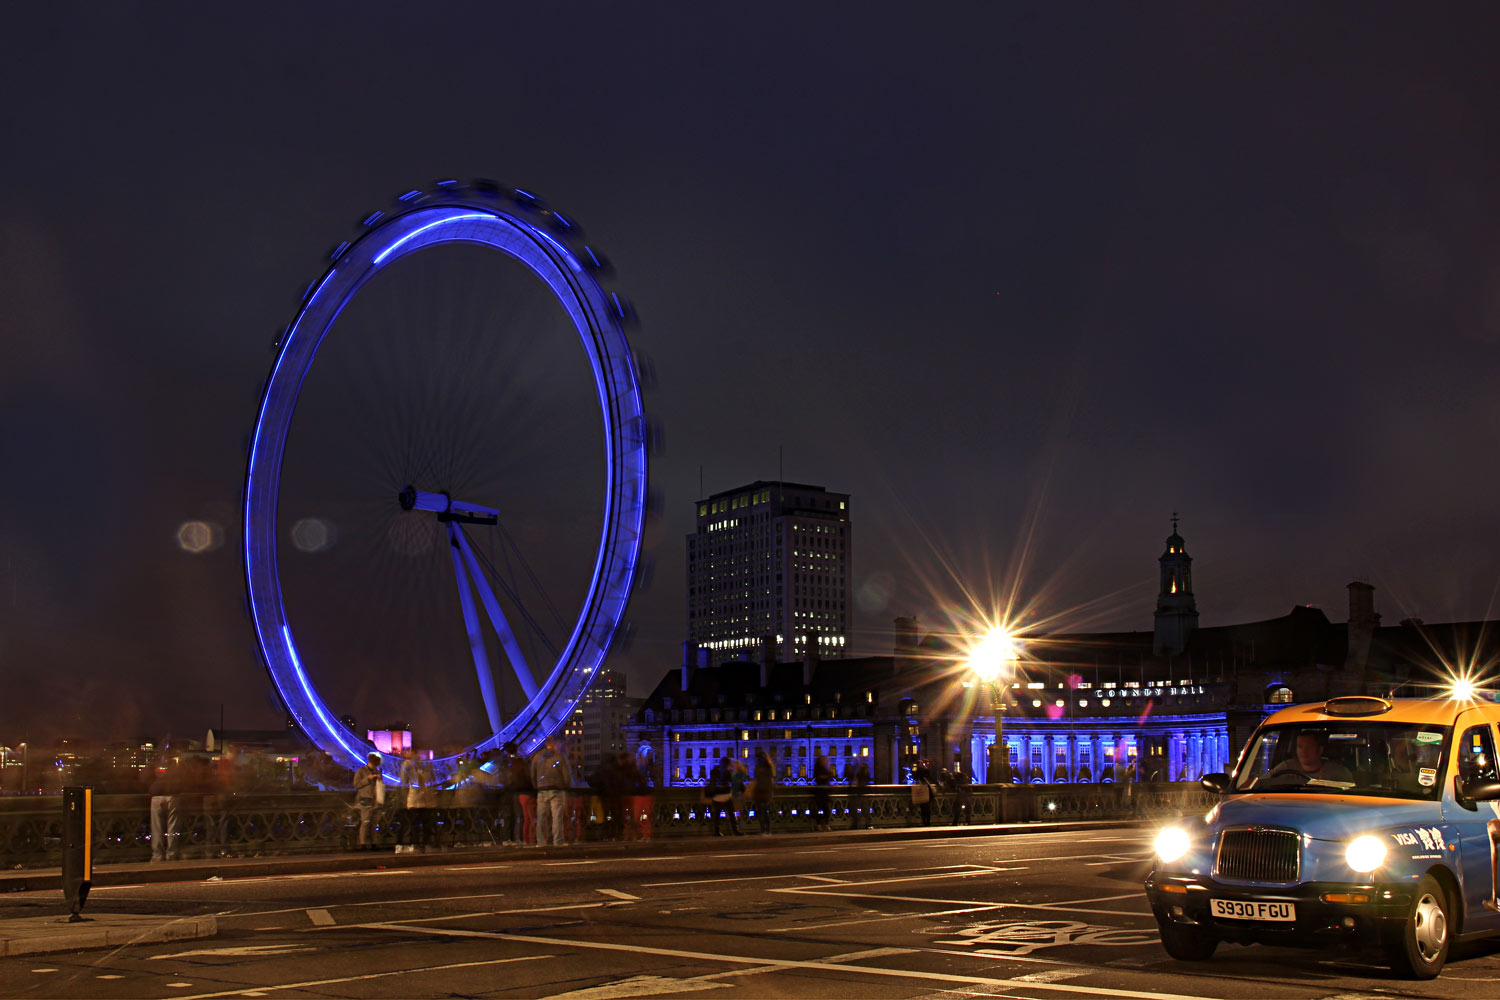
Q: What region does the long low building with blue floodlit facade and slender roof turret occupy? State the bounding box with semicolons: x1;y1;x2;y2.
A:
626;522;1497;786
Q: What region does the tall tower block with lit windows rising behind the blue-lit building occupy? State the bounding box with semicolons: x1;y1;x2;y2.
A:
687;481;854;663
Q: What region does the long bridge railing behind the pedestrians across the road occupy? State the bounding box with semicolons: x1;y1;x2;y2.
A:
0;783;1217;868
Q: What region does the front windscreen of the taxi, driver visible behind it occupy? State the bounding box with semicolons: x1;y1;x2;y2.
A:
1235;721;1452;799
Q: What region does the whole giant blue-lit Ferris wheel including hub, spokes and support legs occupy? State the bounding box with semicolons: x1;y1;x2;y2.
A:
243;181;653;771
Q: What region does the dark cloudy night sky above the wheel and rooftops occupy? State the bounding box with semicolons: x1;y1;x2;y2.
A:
0;3;1500;742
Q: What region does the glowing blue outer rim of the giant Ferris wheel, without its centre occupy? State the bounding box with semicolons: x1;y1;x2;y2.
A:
243;181;651;772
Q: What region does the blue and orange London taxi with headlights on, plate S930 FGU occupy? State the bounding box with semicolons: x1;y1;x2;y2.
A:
1146;696;1500;979
